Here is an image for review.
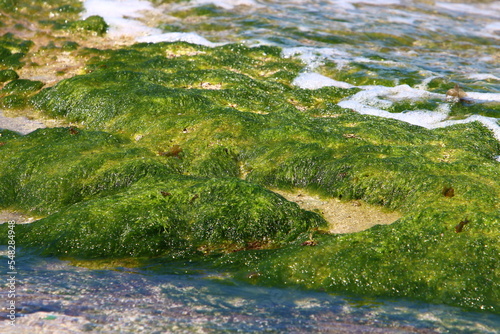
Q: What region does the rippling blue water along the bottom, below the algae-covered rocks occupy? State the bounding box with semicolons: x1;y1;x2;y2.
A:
0;247;500;333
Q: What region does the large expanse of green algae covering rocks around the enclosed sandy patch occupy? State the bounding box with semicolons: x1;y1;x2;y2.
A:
0;43;500;312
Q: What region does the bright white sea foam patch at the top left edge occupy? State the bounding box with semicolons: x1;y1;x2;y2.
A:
83;0;161;37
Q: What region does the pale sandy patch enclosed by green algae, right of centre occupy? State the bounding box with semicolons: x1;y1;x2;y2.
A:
273;190;401;233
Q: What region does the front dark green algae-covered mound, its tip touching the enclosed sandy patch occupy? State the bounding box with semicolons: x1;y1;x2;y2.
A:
5;175;324;258
